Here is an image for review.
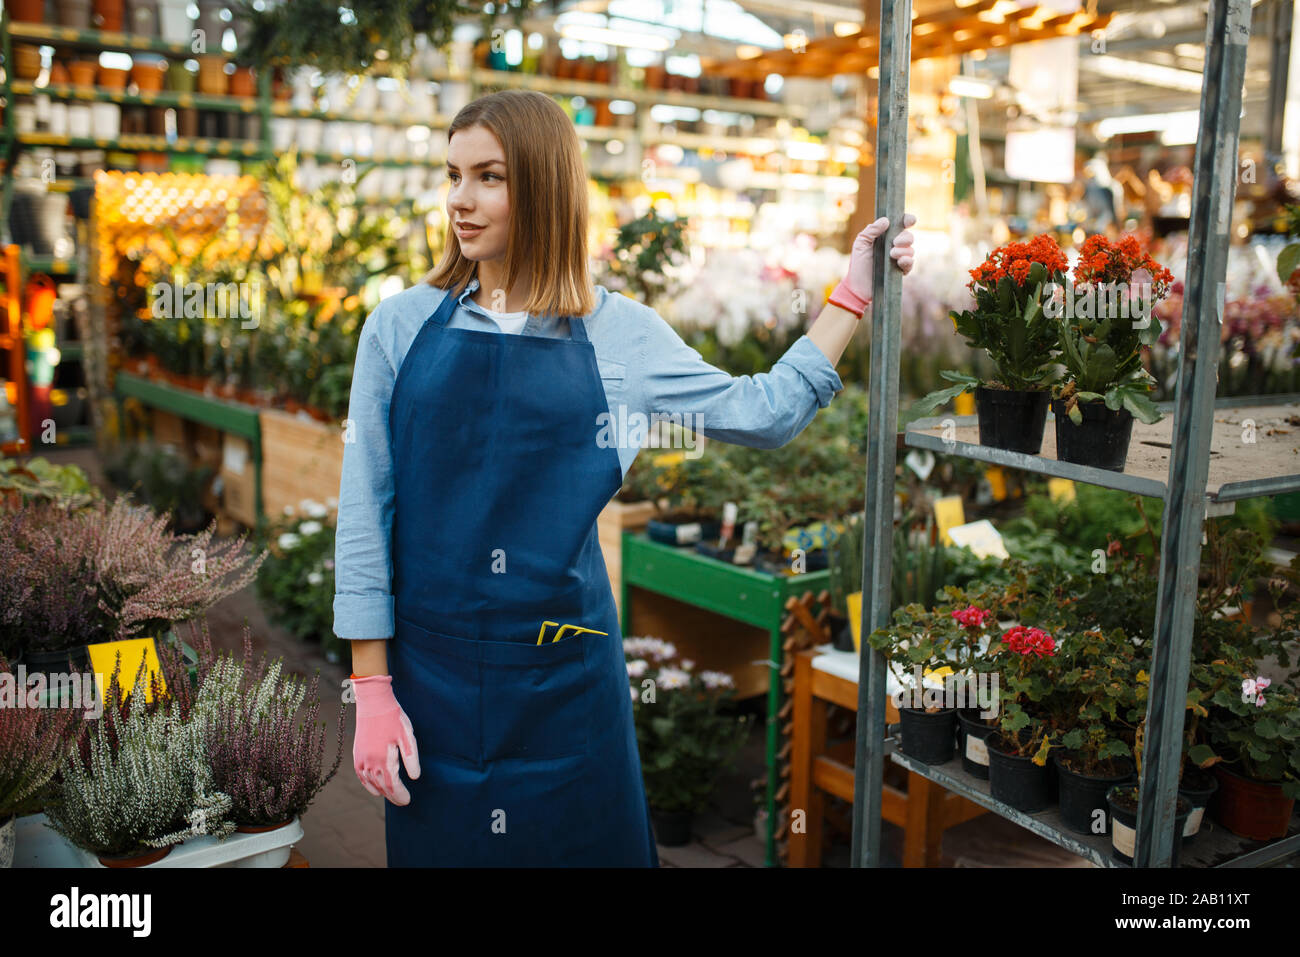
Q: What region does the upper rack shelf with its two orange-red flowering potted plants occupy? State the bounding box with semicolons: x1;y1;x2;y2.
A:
905;235;1300;503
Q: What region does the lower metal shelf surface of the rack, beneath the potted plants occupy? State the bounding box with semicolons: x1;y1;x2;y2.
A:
889;749;1300;867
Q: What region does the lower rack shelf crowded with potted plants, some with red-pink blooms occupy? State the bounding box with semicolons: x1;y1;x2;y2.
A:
870;525;1300;867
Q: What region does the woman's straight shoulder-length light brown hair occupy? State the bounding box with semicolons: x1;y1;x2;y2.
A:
424;90;595;316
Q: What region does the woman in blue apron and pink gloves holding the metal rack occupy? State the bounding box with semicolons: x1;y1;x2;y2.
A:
334;91;911;866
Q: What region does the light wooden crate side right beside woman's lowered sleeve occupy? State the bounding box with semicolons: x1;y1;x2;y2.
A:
259;410;343;520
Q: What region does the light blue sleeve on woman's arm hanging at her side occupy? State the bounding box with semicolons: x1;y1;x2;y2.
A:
334;307;397;638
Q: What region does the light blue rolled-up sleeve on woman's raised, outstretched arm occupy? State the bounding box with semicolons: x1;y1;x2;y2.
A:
638;313;844;449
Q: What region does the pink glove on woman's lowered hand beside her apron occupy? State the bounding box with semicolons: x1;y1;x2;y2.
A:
352;675;420;806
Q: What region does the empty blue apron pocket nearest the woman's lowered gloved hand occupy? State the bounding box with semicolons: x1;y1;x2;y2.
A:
389;616;482;765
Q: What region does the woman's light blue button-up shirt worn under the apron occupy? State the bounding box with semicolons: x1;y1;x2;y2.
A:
334;273;844;638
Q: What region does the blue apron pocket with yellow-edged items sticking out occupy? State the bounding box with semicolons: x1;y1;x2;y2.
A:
478;635;592;761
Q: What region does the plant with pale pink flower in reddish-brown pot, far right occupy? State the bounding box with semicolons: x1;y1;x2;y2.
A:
1188;659;1300;841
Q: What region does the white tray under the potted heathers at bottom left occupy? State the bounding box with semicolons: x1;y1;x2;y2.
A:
13;814;303;869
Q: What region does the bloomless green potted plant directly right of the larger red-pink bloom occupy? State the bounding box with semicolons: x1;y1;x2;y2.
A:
1049;629;1144;833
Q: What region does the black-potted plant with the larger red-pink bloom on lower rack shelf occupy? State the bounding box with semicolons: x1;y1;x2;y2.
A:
984;624;1060;814
